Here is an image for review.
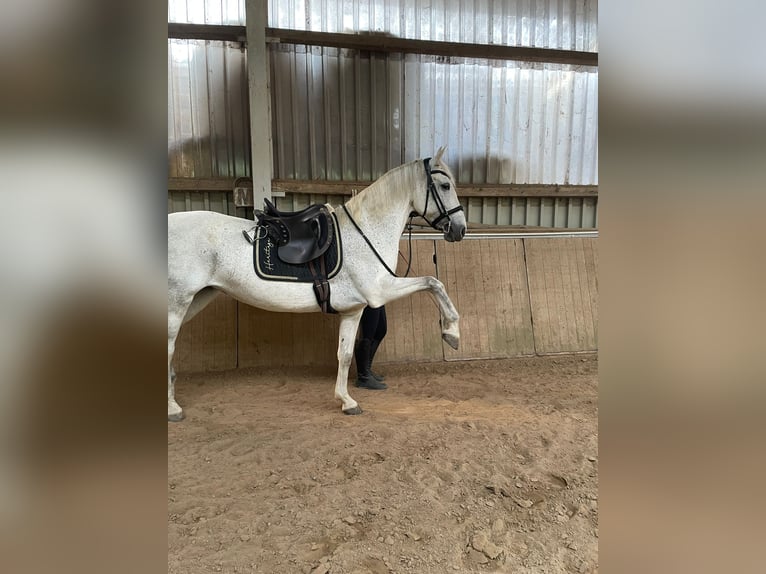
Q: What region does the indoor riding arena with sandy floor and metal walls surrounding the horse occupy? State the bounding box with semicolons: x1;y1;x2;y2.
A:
167;0;599;574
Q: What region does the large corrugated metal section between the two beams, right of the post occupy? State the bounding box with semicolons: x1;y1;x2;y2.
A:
271;45;598;185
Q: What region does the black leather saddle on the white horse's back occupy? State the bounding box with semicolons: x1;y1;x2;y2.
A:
255;199;334;265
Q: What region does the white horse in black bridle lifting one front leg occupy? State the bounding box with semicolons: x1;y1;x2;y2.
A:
168;148;466;421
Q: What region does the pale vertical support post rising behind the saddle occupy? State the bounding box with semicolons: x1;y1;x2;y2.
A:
246;0;272;214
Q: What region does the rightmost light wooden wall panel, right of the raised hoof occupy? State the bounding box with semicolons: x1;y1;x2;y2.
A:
524;238;598;354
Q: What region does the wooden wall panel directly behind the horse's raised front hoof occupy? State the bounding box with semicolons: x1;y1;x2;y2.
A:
437;239;534;360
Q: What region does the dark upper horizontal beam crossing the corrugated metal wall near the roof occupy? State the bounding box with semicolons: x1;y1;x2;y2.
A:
168;22;598;67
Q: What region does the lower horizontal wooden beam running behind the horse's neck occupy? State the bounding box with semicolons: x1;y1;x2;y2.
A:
168;177;598;197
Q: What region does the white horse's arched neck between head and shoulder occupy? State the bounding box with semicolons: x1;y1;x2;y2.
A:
346;162;417;241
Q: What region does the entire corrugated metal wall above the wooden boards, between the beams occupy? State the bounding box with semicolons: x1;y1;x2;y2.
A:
168;0;598;227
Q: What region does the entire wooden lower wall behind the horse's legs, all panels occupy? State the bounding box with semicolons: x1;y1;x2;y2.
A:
176;235;598;372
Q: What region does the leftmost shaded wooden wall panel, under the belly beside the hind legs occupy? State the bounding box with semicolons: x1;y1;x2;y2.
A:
174;295;239;373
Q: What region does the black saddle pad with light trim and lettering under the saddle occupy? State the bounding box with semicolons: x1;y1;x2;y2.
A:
253;213;343;283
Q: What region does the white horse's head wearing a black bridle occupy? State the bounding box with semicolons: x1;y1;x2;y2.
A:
413;147;466;241
